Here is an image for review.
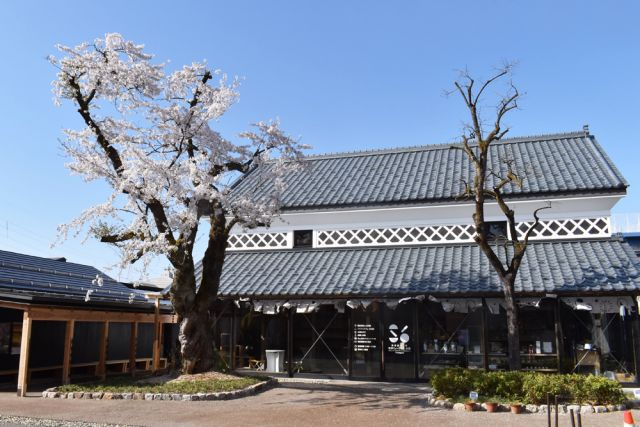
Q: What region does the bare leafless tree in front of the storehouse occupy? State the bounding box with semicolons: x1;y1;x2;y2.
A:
452;64;549;370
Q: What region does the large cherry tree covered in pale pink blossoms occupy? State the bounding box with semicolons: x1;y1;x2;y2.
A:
49;34;307;373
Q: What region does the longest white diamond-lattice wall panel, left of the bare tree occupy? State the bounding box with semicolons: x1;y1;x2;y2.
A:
314;225;475;248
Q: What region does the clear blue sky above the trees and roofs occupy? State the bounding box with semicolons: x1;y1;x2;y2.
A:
0;0;640;279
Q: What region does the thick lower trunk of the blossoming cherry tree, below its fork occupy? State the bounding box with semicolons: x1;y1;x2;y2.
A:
178;306;215;374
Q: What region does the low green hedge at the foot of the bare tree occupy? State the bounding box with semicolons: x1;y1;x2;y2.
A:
431;368;626;405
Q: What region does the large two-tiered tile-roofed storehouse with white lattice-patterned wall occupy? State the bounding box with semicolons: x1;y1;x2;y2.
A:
215;128;640;382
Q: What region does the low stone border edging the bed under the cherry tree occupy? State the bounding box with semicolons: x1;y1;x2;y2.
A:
42;378;277;402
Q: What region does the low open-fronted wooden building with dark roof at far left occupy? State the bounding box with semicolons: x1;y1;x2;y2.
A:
0;250;176;396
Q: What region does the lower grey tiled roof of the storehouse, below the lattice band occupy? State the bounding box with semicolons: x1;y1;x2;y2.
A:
215;239;640;298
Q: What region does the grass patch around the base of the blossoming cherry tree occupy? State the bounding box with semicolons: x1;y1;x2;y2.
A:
56;376;266;394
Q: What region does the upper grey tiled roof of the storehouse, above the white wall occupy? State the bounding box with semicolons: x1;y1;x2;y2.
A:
234;132;627;210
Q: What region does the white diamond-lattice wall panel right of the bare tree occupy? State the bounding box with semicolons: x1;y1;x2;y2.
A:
516;217;611;240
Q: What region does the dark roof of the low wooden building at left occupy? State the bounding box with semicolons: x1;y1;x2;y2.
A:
0;250;152;310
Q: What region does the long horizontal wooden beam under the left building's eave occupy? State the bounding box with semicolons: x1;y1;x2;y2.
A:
29;306;178;323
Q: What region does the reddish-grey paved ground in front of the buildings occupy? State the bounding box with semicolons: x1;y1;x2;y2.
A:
0;382;640;427
